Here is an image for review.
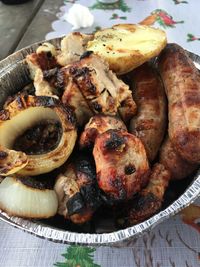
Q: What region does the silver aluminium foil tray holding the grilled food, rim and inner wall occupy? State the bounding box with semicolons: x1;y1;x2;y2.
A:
0;38;200;247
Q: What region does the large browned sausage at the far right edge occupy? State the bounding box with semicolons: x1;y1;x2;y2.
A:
158;44;200;163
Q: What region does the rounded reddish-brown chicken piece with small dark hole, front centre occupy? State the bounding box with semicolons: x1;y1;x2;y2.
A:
93;129;149;200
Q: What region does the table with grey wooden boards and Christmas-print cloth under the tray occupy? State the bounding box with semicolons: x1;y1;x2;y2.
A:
0;0;200;267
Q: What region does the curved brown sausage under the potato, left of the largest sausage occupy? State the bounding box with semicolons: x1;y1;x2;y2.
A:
129;63;167;161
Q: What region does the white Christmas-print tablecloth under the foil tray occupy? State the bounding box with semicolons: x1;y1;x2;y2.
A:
0;0;200;267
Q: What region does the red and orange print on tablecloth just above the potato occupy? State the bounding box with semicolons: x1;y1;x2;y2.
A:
140;9;184;28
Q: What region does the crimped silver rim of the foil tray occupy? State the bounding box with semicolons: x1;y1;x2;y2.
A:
0;41;200;246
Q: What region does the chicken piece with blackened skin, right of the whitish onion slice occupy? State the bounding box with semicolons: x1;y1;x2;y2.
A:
54;154;101;224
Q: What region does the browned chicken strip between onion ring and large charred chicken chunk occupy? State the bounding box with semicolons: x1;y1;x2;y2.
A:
62;80;93;127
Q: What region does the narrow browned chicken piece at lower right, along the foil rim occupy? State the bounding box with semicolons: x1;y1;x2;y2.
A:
128;163;170;225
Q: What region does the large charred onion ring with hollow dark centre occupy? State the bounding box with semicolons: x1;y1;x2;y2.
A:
0;95;77;176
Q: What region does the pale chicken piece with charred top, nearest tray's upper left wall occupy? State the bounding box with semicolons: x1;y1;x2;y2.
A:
26;43;59;98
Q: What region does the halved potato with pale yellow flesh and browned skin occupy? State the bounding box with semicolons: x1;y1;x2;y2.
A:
87;24;167;74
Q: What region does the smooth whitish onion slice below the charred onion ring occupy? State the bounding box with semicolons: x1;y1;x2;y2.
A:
0;177;58;219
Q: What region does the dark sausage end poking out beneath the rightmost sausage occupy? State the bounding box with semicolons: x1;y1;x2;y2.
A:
159;137;198;180
